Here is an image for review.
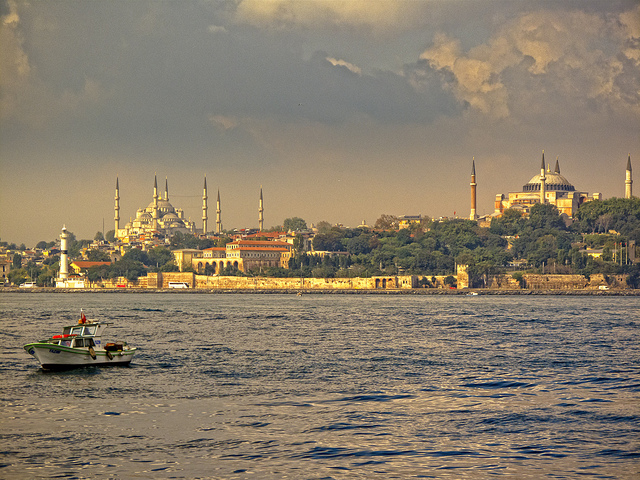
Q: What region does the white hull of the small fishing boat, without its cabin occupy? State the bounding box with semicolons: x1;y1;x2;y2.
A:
24;343;136;370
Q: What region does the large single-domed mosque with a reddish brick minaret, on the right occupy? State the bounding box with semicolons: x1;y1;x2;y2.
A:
469;152;633;220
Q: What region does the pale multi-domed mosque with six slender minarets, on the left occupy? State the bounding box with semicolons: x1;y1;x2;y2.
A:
114;176;264;243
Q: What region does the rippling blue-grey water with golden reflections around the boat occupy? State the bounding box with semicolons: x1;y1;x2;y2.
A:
0;293;640;479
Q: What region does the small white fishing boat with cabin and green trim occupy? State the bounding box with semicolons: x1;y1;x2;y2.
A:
24;313;136;370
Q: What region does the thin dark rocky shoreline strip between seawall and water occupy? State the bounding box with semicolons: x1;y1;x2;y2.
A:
0;287;640;297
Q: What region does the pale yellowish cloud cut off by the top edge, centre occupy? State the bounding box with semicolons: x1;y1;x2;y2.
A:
236;0;423;32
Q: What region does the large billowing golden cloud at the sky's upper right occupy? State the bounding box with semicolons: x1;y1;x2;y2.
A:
420;7;640;119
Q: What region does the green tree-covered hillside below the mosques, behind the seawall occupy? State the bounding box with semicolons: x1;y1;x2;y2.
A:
4;198;640;286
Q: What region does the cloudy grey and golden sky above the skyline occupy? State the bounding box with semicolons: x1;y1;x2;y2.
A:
0;0;640;246
